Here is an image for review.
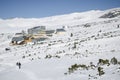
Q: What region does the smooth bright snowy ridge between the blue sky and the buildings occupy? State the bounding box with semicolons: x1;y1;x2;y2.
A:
0;8;120;32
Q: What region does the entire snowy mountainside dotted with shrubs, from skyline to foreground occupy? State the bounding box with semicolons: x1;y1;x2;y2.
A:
0;8;120;80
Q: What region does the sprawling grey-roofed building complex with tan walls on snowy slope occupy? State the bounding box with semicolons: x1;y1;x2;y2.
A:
11;26;66;45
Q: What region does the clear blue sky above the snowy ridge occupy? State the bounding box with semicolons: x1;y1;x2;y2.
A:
0;0;120;19
